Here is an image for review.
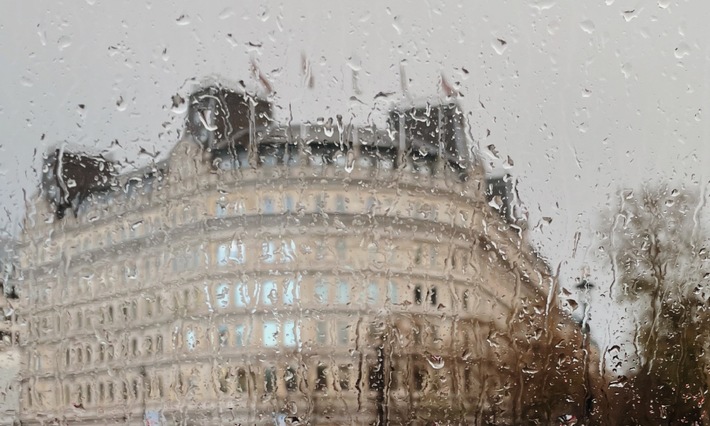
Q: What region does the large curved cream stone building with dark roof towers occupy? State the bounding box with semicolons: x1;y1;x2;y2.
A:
15;87;583;425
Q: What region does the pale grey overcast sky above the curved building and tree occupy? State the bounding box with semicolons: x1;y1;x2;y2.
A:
0;0;710;352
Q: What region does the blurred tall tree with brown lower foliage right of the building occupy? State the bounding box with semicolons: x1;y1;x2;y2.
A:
602;185;710;424
